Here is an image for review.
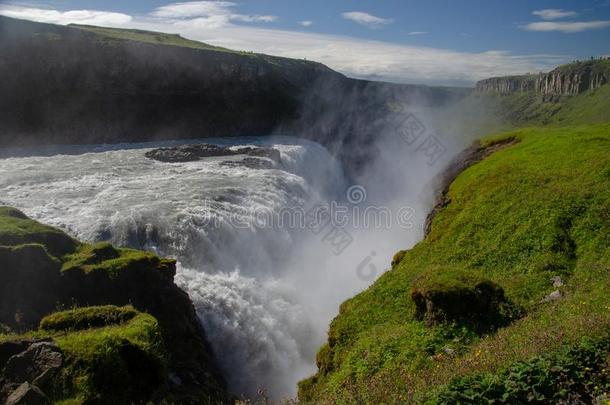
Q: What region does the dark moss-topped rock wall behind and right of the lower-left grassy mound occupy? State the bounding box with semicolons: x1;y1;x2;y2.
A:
0;207;227;403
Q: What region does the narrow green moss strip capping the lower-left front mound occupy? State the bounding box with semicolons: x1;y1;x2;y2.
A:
40;305;138;331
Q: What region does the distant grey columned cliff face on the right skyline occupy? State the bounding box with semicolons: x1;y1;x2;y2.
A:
476;60;610;97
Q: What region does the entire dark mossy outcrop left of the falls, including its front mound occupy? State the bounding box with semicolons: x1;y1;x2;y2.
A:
0;207;228;404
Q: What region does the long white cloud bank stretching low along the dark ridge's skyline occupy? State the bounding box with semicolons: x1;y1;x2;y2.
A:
0;6;573;85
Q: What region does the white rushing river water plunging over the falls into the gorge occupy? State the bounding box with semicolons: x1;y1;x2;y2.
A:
0;138;440;399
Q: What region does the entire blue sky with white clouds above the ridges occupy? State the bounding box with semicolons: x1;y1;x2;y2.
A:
0;0;610;85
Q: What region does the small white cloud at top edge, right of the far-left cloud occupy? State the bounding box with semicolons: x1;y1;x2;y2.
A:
151;1;277;28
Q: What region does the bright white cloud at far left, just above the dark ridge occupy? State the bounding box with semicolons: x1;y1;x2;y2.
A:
0;4;132;27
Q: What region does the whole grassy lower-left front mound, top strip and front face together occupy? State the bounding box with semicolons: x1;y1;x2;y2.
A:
0;306;167;404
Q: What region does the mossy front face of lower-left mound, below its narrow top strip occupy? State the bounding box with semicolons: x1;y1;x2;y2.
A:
53;314;165;403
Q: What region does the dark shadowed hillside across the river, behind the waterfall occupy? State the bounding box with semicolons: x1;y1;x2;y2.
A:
0;16;469;161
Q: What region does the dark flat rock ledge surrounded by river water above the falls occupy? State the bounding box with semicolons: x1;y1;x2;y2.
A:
145;143;281;163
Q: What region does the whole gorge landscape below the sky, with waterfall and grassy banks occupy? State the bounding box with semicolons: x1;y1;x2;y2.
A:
0;12;610;404
